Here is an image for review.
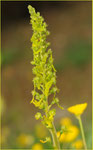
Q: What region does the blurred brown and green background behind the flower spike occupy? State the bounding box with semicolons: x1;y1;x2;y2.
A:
1;1;92;150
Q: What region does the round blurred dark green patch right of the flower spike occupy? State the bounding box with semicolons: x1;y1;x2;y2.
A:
66;41;92;67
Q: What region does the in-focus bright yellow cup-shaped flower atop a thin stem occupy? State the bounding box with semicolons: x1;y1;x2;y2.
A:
67;103;87;116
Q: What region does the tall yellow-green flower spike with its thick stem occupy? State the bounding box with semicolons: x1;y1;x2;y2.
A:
28;5;63;149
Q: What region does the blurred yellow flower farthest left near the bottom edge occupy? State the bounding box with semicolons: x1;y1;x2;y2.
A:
17;134;34;147
